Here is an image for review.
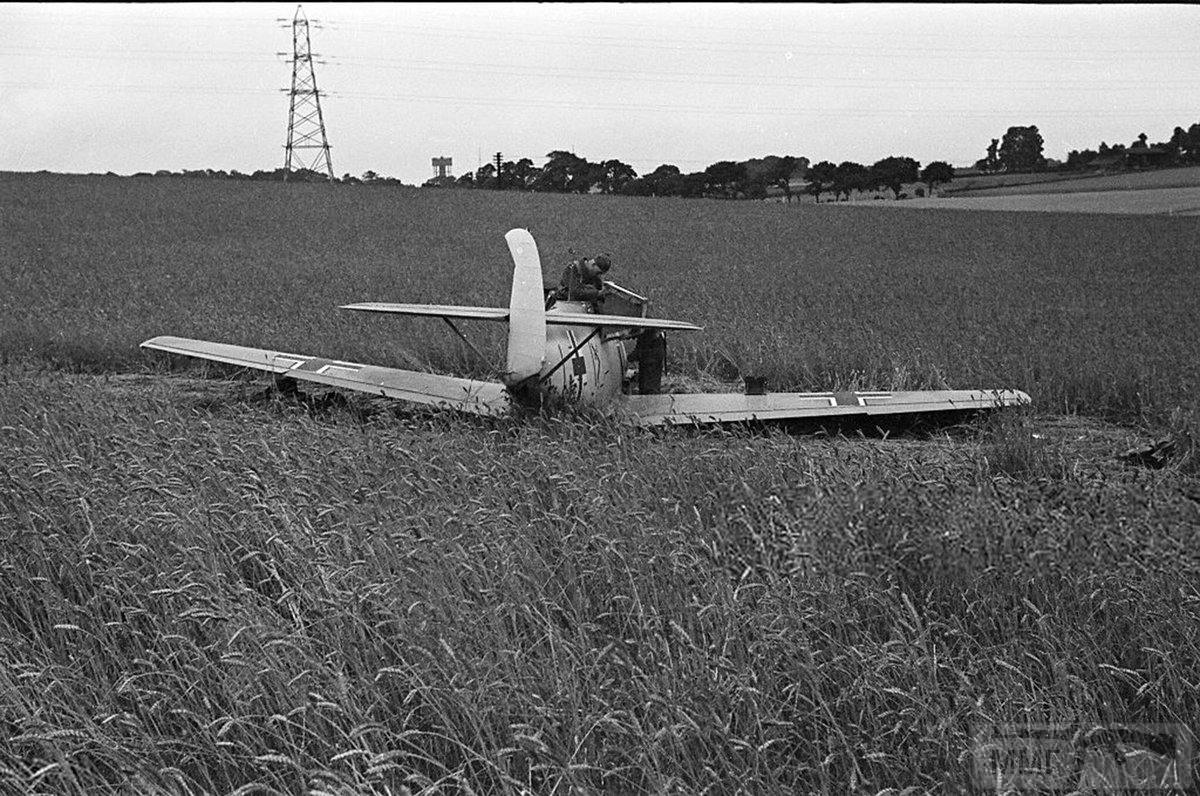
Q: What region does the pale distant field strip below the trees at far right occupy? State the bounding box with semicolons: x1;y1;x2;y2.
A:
873;183;1200;216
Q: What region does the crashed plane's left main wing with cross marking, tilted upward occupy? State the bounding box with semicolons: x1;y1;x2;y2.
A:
142;336;509;415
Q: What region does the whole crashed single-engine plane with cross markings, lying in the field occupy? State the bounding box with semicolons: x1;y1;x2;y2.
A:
142;229;1030;425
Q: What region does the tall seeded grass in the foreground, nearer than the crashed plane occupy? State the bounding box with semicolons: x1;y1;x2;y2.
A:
0;369;1200;794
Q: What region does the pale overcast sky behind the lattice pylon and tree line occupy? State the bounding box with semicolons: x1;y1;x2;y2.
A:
0;2;1200;182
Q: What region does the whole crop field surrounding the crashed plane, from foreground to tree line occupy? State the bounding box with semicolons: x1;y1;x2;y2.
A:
0;175;1200;794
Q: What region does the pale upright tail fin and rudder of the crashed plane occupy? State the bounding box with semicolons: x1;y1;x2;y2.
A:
504;229;546;389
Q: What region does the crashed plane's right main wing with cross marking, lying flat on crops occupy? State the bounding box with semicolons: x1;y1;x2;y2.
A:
622;390;1030;425
